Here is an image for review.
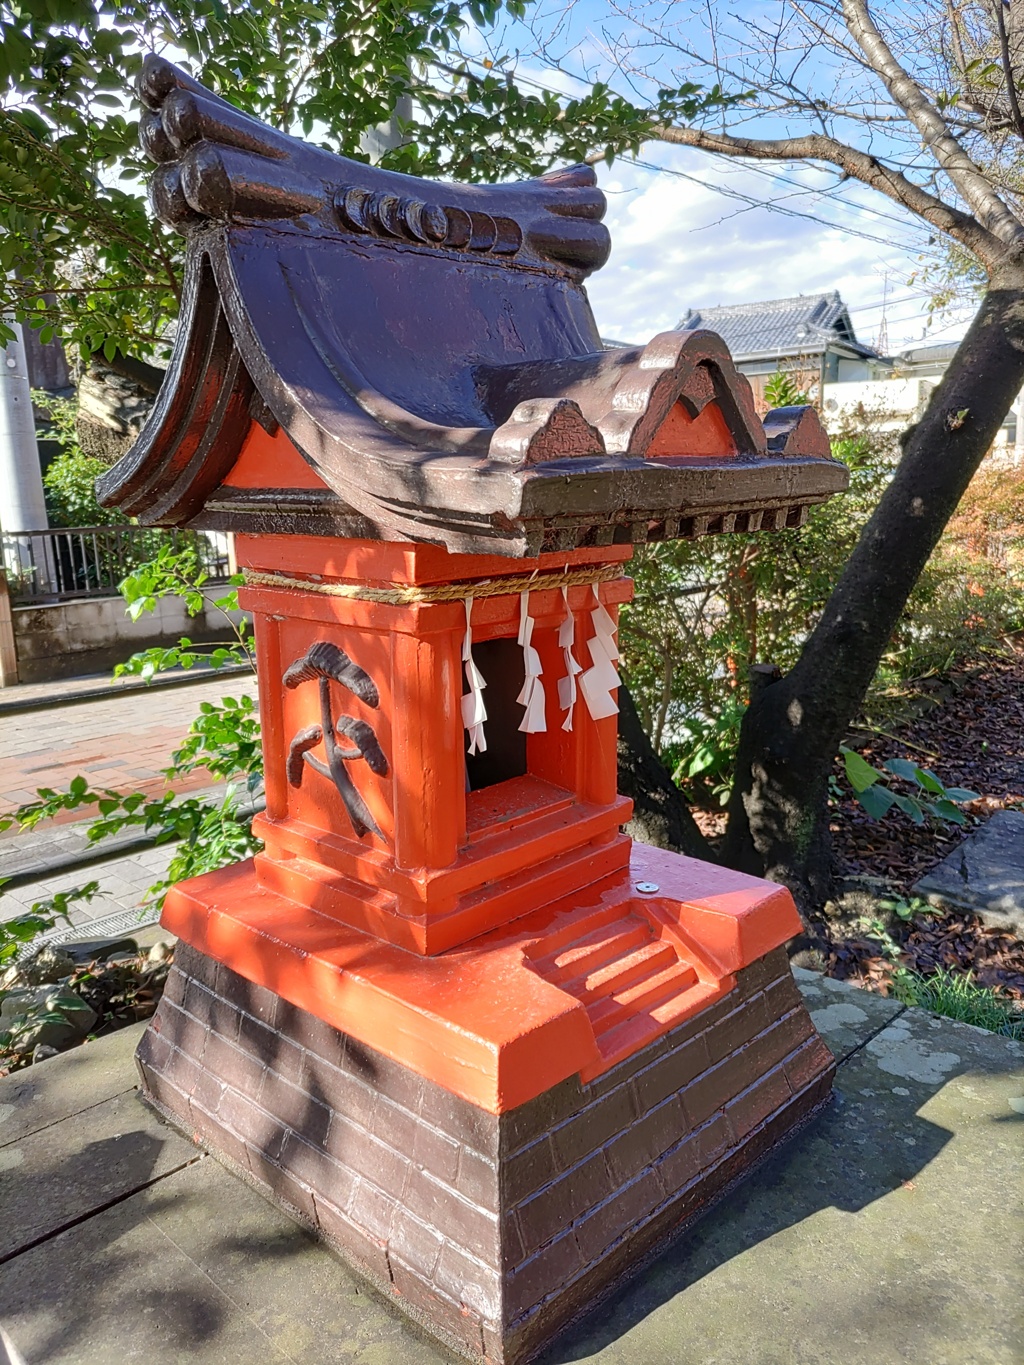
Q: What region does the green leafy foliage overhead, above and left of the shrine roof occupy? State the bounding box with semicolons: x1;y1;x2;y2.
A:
0;0;724;360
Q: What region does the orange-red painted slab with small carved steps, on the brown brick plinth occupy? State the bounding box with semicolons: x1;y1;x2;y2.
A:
162;845;800;1114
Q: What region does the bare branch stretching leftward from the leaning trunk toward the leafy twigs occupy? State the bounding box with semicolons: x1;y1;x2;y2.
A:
653;126;1004;269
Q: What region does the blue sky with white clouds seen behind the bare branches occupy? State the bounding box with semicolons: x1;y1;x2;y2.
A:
479;0;971;354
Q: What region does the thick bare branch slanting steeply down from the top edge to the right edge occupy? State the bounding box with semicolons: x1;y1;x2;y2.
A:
842;0;1024;244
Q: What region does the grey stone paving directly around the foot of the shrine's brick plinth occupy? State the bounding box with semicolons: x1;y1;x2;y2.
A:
0;972;1024;1365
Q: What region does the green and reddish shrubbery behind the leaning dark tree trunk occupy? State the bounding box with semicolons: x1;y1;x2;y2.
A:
621;412;1024;808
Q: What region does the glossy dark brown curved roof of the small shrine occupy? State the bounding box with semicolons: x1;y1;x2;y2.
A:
98;57;847;557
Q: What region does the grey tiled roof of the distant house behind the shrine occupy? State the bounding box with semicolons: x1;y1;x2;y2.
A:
679;289;878;363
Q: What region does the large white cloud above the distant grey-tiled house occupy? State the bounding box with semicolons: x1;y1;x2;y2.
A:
587;149;965;351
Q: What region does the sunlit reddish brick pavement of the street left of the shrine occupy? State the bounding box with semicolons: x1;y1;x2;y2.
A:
0;674;255;813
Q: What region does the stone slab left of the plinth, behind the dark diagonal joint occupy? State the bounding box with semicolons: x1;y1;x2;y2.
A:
0;1091;198;1263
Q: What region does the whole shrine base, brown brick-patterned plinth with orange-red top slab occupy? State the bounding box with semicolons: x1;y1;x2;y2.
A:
146;845;834;1365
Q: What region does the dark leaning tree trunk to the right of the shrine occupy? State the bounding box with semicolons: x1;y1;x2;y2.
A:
722;281;1024;927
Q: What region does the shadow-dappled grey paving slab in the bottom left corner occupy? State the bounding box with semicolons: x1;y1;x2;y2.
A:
0;1158;451;1365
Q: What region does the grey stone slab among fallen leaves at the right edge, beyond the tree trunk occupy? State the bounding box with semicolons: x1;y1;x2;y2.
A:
913;811;1024;938
